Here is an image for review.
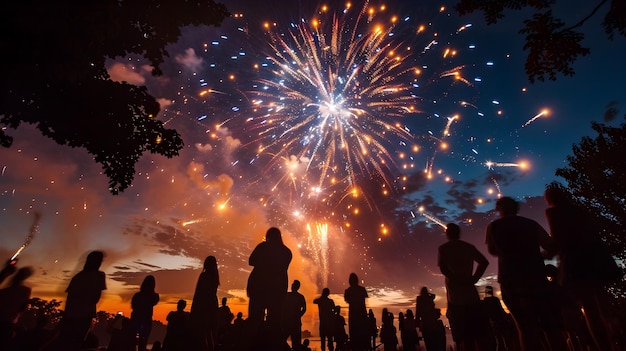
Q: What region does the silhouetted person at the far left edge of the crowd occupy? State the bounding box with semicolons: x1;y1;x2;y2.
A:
0;267;33;350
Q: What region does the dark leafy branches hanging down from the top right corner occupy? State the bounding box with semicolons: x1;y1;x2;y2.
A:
455;0;626;83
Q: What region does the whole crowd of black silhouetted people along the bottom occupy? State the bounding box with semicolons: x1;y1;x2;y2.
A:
0;187;626;351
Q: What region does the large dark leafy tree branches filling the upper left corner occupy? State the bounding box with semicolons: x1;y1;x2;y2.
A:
0;0;229;194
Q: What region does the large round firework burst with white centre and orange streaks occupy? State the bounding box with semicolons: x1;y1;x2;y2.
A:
244;3;448;209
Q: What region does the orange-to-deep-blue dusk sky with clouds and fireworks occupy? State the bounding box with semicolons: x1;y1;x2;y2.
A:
0;0;626;328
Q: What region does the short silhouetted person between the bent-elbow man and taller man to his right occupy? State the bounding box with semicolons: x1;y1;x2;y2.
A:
483;285;517;351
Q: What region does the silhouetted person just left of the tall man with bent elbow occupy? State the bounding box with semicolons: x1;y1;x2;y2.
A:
415;286;446;351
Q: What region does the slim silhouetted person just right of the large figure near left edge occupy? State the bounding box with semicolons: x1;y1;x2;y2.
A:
130;275;159;351
